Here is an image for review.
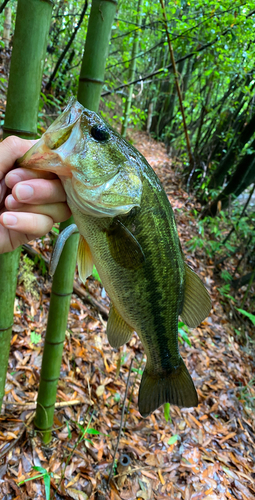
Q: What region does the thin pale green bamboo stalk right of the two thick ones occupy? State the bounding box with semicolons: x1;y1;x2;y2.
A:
121;0;143;137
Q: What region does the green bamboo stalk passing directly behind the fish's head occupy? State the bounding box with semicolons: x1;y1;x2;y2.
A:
34;0;117;443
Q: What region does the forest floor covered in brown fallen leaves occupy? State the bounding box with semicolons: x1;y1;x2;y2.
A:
0;132;255;500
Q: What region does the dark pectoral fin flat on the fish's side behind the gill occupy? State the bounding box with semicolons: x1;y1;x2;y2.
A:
107;220;145;269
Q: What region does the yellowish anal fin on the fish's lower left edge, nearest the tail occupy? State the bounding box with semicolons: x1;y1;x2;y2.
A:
106;305;134;347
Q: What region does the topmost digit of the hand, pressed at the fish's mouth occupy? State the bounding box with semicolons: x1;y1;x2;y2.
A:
0;135;36;180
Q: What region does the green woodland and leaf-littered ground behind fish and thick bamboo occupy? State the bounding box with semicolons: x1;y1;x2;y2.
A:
0;0;255;500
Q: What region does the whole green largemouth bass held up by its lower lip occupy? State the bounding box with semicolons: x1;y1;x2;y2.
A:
19;98;211;417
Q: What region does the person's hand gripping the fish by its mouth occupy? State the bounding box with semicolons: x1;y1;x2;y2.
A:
0;136;71;254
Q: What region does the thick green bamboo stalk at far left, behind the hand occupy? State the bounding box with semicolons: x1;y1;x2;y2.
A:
0;0;52;411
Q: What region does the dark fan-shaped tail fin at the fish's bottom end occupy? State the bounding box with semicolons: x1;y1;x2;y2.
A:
138;359;198;417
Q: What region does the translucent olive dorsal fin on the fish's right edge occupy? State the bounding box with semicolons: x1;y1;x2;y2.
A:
181;263;212;328
